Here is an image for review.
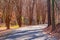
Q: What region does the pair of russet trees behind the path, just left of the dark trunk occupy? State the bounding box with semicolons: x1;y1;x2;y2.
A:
36;0;47;24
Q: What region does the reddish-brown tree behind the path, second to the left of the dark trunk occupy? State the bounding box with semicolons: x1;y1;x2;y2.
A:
36;0;42;24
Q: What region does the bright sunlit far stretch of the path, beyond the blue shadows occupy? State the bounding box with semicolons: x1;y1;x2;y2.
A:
17;24;47;30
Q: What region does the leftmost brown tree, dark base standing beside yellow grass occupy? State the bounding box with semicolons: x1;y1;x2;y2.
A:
1;0;10;29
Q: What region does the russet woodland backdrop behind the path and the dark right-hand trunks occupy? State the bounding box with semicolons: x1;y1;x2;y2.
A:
0;0;60;29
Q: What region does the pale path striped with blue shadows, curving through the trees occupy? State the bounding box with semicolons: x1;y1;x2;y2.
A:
5;25;57;40
